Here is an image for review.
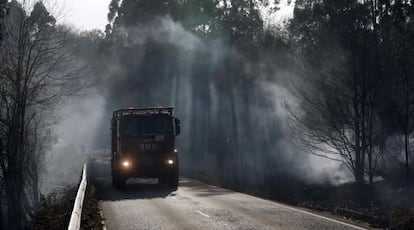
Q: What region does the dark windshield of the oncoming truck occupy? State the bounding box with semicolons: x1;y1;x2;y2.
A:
120;117;173;136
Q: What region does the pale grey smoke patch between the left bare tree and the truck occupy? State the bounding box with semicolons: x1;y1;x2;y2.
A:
41;93;109;194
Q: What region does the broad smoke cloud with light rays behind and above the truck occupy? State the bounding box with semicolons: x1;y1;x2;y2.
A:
43;17;349;193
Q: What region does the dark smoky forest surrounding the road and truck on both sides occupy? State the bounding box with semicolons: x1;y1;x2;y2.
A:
0;0;414;229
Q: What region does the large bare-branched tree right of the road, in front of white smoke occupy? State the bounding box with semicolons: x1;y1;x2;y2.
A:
290;0;389;184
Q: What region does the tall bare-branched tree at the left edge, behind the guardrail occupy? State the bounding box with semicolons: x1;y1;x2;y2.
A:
0;1;86;229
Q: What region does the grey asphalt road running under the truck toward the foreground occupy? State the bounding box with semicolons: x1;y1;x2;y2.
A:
88;158;363;230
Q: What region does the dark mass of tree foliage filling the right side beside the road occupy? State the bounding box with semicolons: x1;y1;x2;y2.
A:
289;0;414;184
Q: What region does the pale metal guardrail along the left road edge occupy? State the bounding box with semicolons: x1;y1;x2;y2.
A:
68;164;87;230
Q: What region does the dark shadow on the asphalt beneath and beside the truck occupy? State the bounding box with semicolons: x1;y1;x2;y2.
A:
88;158;175;201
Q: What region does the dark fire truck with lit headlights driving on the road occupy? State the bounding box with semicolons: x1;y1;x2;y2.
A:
111;107;180;190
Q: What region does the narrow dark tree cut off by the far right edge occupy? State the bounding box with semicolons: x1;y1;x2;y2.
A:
382;1;414;179
